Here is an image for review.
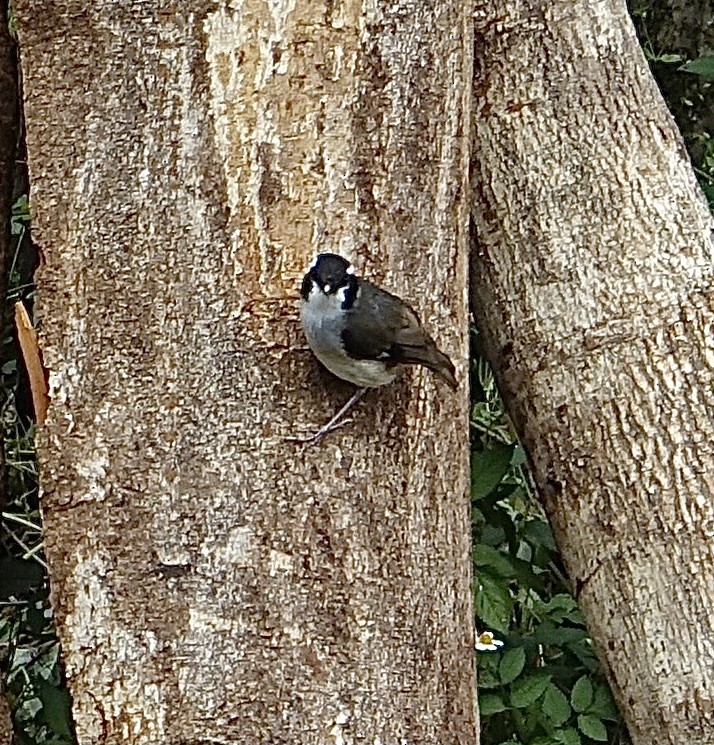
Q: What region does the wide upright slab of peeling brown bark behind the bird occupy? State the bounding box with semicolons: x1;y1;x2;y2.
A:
17;0;477;745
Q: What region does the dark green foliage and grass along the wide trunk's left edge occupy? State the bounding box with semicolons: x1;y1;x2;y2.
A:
0;195;74;745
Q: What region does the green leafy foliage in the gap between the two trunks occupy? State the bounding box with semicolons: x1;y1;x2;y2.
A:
472;359;628;745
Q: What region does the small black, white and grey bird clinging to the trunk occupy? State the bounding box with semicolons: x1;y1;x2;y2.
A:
291;253;457;442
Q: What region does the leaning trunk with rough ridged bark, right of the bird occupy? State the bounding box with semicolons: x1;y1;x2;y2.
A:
472;0;714;745
